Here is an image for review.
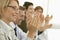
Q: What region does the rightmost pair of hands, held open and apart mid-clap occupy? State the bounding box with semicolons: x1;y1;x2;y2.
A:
38;15;53;31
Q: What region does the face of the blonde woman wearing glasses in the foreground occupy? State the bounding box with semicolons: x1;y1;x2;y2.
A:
4;1;19;21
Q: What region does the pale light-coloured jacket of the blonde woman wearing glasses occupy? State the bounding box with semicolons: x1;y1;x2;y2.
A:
0;20;18;40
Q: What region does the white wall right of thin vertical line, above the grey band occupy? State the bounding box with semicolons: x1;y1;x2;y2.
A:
49;0;60;24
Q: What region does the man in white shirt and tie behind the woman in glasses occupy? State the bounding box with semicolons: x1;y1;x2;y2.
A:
9;6;26;40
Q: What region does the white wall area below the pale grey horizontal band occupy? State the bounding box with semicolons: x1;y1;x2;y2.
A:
46;29;60;40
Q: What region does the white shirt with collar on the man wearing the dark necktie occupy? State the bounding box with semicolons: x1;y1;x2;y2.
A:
9;22;26;40
